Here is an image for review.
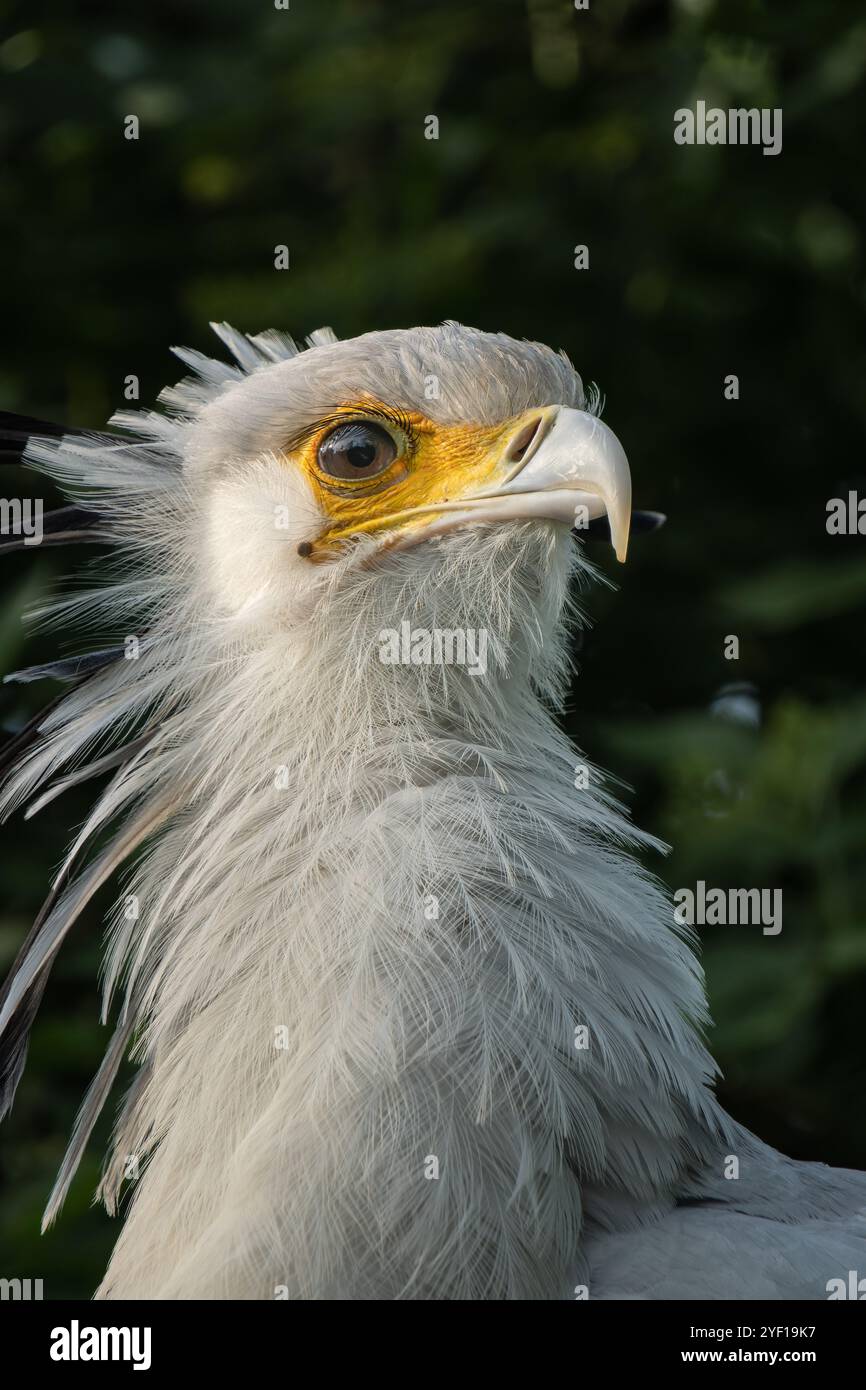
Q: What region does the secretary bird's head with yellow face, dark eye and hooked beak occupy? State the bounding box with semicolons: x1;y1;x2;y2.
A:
173;324;631;631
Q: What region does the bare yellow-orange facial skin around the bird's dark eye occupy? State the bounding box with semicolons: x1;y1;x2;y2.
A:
282;399;520;560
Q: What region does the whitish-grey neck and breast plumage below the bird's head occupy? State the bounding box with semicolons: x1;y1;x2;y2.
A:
86;527;716;1298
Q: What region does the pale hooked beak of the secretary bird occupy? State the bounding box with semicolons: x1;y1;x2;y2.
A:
397;406;631;560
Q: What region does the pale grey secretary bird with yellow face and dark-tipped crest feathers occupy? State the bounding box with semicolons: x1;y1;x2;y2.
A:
0;322;866;1300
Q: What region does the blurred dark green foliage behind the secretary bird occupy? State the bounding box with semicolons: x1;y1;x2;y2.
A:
0;0;866;1297
